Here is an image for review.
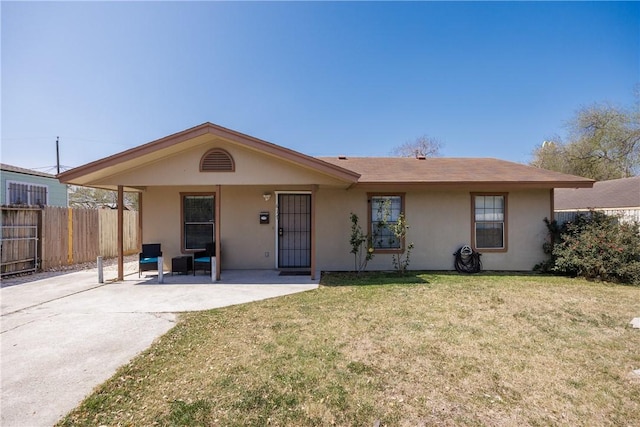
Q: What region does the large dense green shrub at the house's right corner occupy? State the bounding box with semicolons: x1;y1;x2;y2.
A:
537;211;640;285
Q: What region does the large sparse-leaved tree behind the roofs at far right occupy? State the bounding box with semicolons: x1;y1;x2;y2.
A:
530;104;640;181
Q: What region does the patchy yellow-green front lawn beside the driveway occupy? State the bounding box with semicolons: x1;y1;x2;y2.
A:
59;273;640;426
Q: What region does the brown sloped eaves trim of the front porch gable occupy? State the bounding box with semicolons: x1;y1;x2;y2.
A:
58;122;360;187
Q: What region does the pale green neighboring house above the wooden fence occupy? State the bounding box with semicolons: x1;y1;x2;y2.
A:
0;164;68;207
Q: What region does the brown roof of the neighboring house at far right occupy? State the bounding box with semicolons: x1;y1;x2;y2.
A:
554;176;640;210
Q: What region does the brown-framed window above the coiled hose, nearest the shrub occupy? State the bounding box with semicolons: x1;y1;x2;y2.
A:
471;194;507;250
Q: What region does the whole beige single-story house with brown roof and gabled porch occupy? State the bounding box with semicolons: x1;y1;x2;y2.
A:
59;123;593;277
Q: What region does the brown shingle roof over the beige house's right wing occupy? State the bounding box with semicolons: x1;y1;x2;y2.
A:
320;157;593;188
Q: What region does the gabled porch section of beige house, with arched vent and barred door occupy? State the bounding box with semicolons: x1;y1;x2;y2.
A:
58;123;360;280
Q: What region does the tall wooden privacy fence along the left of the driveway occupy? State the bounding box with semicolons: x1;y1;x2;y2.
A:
2;206;139;275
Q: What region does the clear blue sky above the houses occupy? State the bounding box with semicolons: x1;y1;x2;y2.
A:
0;1;640;173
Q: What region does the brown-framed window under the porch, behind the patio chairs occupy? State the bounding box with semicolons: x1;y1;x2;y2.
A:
181;193;215;251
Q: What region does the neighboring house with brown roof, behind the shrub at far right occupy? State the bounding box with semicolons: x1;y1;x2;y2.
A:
554;176;640;223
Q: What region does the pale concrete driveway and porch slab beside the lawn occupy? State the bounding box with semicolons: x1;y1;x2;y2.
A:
0;270;318;427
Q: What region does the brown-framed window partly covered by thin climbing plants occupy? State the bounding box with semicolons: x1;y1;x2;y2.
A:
369;194;404;251
